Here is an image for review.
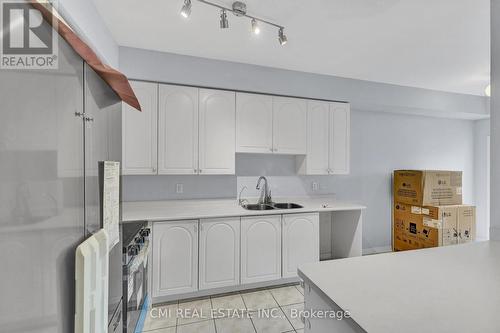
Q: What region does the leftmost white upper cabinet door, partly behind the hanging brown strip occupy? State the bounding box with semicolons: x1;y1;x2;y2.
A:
122;82;158;175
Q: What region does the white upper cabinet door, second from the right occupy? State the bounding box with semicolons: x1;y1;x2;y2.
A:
306;101;330;175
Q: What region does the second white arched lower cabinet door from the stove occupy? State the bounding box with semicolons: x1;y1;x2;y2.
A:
200;217;240;290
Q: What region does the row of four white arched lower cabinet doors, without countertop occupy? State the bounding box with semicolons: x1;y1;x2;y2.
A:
151;213;319;298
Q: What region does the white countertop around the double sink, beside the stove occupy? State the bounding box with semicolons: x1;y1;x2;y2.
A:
122;196;366;222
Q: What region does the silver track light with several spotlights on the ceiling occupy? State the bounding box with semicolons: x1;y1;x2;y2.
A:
181;0;288;46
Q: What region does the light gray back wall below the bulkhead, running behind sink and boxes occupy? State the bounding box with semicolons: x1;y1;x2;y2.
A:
123;110;475;249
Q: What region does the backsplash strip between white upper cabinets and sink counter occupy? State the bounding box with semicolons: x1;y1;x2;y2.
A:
122;154;334;201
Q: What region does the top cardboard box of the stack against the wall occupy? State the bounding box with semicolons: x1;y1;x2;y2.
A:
393;170;462;206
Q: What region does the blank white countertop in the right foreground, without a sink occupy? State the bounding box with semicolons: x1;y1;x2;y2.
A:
299;241;500;333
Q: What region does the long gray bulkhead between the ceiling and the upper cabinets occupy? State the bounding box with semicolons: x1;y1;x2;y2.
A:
120;47;489;119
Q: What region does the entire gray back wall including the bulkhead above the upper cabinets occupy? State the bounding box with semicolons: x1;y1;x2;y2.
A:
120;48;488;249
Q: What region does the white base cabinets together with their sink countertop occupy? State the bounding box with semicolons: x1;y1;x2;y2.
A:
122;197;365;303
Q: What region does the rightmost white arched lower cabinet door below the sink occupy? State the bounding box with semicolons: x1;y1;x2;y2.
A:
283;213;319;278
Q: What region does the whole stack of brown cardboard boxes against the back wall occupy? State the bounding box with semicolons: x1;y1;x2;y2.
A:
392;170;476;251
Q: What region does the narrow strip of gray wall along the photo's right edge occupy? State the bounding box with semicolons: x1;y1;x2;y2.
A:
490;0;500;240
